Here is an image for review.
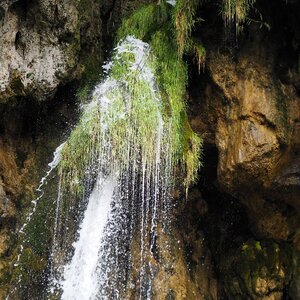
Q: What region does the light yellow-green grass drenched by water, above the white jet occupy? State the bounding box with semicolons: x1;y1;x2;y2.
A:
60;39;166;193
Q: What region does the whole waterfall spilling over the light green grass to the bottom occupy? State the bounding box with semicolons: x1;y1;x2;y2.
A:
44;36;197;300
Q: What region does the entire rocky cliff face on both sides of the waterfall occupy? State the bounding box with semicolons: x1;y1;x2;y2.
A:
0;0;300;300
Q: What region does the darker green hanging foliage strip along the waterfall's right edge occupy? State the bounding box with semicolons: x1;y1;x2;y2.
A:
118;0;206;186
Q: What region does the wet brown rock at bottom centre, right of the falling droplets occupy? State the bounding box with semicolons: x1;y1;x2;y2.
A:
123;189;218;300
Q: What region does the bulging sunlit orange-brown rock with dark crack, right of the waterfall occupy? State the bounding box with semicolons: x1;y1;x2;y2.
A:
209;55;288;191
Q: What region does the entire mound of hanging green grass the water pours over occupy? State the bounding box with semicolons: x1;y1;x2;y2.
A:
60;1;205;192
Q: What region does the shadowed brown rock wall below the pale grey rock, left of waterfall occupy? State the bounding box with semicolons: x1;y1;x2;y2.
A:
0;92;76;299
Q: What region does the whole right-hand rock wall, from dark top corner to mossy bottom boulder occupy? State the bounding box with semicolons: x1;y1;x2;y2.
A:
190;2;300;299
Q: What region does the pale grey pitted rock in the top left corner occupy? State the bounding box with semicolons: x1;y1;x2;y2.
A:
0;0;101;102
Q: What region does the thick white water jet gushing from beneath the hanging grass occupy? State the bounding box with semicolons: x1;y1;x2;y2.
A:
62;175;116;300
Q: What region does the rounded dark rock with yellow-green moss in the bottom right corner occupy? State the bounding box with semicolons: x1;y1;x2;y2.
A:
224;240;293;299
